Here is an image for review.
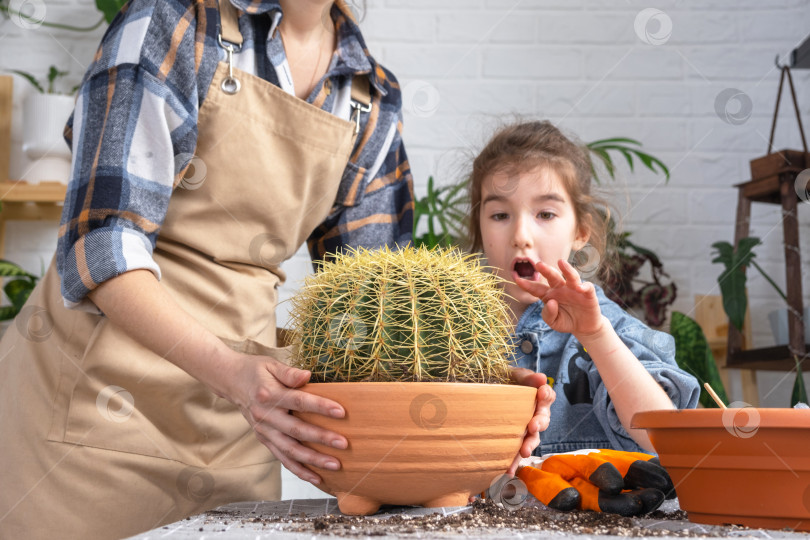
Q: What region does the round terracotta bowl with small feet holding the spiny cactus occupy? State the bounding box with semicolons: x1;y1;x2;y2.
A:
295;382;537;515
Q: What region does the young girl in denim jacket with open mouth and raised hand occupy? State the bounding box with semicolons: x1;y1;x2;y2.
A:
470;122;700;455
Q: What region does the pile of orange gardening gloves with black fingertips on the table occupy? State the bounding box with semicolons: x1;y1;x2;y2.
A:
517;450;675;516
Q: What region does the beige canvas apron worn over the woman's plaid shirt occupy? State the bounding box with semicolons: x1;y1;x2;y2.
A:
0;1;367;538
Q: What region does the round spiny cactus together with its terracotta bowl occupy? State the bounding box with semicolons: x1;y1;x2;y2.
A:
291;247;537;515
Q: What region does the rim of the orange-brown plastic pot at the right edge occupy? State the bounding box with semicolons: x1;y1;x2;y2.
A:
630;407;810;429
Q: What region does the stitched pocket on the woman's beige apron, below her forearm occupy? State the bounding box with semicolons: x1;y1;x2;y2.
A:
58;319;275;467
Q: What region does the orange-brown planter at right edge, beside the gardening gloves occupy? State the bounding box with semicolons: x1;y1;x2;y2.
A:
632;407;810;531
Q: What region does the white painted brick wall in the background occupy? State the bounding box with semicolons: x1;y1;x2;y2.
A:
0;0;810;494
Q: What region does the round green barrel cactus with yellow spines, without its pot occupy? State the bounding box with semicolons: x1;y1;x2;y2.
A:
291;247;511;383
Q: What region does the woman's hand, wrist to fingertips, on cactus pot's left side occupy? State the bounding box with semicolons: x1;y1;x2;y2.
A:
222;355;348;485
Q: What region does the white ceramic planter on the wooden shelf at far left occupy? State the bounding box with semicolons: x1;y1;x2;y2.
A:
22;92;74;184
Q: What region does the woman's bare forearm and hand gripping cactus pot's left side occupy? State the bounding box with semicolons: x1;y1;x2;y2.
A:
90;270;348;484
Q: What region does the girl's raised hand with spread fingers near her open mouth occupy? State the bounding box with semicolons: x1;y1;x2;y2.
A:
516;259;603;341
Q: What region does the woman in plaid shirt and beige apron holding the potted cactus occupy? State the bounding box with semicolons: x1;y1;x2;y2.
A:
0;0;550;538
